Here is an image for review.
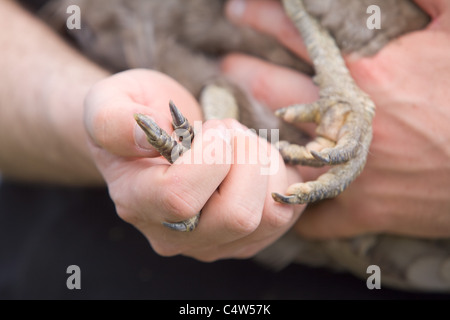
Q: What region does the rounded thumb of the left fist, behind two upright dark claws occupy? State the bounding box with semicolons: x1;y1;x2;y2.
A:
85;70;200;157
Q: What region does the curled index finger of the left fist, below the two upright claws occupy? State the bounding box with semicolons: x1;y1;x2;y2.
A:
102;121;236;256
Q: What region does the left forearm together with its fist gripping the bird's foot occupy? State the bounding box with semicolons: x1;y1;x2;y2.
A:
0;0;304;261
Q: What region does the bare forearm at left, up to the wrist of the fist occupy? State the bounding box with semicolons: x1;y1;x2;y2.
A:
0;0;107;184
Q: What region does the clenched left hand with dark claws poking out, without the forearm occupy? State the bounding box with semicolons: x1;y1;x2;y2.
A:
85;70;303;261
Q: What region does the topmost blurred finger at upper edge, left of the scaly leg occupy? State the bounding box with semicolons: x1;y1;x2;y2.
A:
225;0;310;61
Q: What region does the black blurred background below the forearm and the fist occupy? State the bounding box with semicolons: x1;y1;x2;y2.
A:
0;181;450;300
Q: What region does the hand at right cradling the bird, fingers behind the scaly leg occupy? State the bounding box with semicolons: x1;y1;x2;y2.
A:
222;0;450;238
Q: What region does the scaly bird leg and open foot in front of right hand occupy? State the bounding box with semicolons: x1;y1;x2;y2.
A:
272;0;375;204
